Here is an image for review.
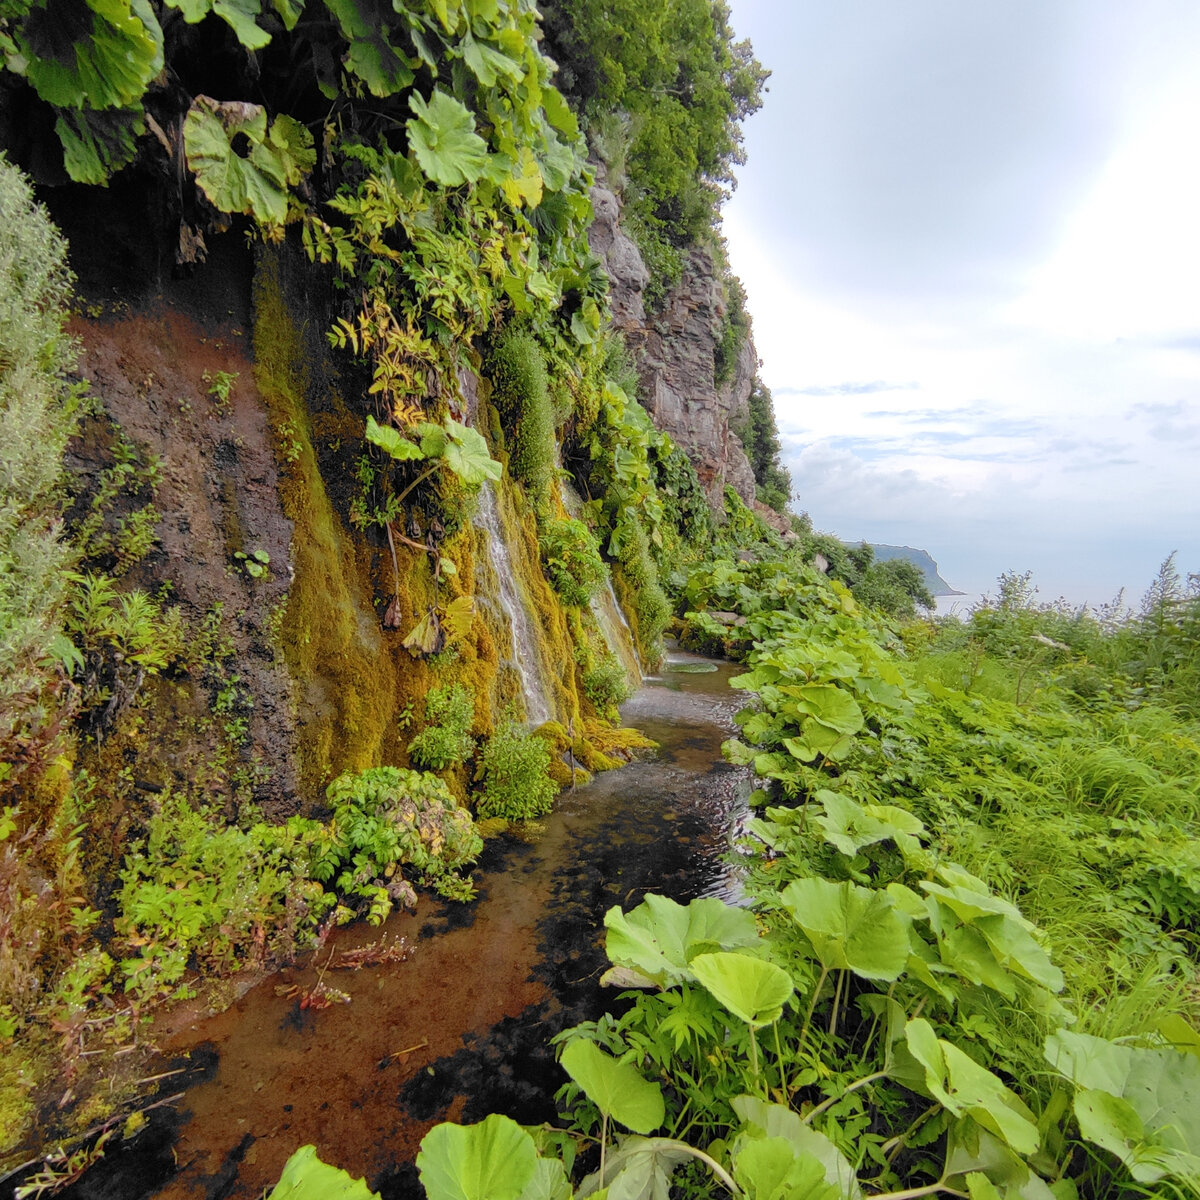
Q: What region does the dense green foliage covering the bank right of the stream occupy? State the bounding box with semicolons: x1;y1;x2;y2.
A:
422;550;1200;1200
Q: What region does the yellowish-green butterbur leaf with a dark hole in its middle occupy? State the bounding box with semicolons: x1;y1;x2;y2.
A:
184;96;316;224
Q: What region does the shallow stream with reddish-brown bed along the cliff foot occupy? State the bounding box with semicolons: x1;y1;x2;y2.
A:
71;654;749;1200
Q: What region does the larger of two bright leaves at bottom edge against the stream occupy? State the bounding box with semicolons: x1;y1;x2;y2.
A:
416;1112;538;1200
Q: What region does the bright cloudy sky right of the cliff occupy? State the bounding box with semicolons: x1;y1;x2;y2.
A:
725;0;1200;605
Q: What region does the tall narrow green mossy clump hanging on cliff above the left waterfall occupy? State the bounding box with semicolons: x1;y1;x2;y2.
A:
488;331;554;500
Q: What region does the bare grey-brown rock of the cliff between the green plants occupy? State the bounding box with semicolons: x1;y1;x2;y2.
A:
589;185;758;508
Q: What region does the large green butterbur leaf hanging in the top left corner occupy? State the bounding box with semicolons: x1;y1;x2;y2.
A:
16;0;163;109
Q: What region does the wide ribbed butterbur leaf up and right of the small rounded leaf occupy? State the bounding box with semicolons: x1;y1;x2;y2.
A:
780;878;908;982
